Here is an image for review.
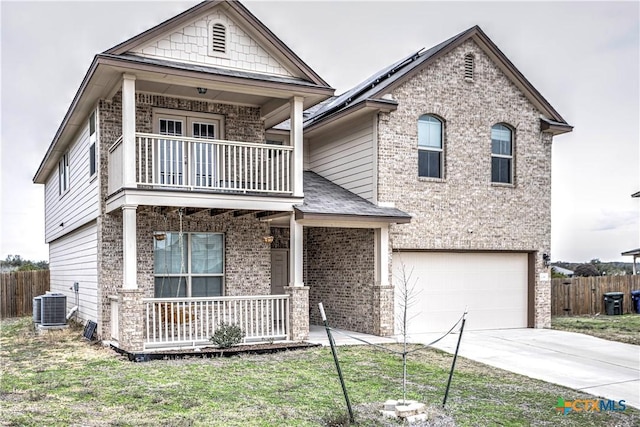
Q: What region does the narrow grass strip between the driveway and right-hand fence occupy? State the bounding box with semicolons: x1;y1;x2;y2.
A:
551;314;640;345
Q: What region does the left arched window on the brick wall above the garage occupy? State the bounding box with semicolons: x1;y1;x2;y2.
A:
418;114;444;178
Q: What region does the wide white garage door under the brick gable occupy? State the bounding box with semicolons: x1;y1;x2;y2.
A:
393;252;528;335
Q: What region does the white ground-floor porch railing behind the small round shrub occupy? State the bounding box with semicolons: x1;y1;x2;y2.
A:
143;295;289;350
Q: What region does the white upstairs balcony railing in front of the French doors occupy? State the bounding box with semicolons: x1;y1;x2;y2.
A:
136;133;293;194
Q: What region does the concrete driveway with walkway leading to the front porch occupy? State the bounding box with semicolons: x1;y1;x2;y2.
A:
308;326;640;409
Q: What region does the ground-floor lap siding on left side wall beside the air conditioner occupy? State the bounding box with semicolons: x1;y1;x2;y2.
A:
49;222;98;321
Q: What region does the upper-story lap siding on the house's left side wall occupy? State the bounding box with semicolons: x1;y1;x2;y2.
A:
44;122;99;243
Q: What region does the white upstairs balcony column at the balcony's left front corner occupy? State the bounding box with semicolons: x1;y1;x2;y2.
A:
122;74;136;188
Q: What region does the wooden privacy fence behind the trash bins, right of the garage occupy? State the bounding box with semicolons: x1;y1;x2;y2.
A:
551;275;640;316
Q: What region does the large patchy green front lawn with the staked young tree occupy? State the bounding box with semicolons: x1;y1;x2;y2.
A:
0;318;640;426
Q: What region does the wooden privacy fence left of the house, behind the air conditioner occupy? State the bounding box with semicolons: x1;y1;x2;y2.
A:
0;270;49;319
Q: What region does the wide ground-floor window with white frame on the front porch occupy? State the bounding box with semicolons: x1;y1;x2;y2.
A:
153;233;224;298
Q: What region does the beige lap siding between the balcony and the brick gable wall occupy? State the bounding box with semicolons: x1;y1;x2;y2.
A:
309;117;375;203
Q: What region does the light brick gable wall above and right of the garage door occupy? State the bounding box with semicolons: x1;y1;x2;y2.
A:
378;40;552;327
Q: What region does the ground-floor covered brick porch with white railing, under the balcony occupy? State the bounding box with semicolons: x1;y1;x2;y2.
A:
101;206;309;352
